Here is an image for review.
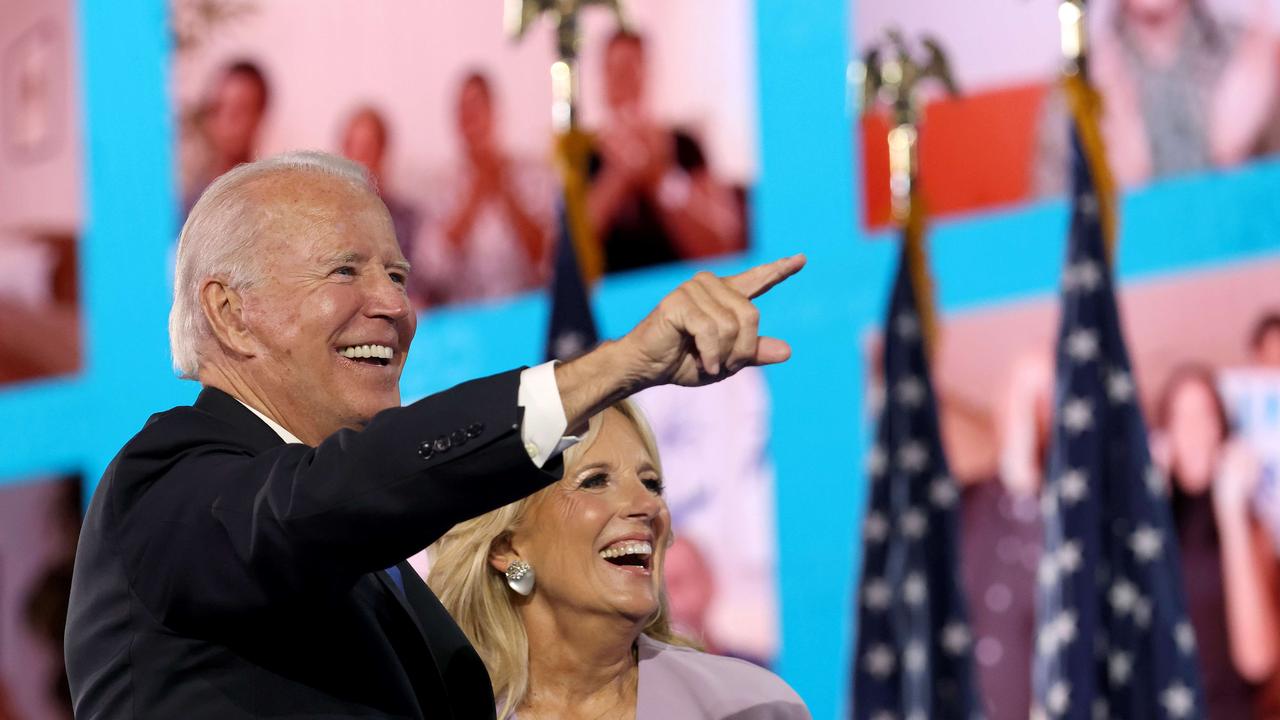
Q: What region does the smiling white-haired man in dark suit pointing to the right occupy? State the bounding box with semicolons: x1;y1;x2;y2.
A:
67;148;804;720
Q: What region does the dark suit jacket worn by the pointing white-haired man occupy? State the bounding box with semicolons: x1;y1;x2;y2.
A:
67;372;559;720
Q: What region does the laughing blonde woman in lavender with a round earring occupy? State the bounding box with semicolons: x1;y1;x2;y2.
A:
429;401;809;720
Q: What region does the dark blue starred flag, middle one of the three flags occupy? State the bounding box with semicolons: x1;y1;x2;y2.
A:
851;237;980;720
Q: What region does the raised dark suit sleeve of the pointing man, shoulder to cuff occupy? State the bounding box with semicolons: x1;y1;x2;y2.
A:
110;372;559;628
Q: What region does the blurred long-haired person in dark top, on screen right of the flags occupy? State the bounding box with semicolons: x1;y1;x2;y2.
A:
1152;364;1280;720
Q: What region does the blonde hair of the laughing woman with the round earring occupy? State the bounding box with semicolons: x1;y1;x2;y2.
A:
428;400;690;720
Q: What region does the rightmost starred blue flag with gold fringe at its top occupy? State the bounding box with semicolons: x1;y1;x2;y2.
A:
1032;78;1204;720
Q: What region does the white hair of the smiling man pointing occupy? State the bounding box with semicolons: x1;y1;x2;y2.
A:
169;151;376;378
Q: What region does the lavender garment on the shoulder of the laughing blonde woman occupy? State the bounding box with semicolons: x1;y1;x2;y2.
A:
636;635;812;720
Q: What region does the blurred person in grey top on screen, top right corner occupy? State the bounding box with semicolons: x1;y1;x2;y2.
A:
1034;0;1280;193
